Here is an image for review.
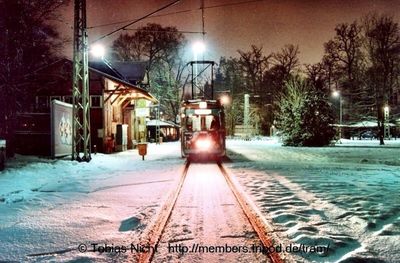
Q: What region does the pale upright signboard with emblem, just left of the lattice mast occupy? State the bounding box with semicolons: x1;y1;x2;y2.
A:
51;100;72;158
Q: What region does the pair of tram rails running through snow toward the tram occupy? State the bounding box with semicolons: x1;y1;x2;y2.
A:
137;162;284;263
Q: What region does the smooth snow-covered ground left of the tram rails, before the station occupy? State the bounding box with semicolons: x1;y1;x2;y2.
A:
0;144;183;262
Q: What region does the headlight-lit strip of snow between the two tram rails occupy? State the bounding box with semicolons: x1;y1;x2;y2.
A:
154;163;268;262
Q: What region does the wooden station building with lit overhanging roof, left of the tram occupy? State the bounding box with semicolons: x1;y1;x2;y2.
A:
16;59;157;155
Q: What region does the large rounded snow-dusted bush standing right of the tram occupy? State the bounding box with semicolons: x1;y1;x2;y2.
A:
277;78;335;146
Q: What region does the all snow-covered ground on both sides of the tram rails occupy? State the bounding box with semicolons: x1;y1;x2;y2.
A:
0;139;400;262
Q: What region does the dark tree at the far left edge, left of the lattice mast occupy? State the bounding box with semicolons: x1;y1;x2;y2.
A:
0;0;67;155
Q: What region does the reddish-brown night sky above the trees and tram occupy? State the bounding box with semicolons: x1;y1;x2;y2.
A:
57;0;400;63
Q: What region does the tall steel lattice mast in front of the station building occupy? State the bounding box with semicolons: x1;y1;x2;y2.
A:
72;0;91;162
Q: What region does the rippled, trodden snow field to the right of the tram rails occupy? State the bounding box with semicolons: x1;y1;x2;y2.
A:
228;140;400;262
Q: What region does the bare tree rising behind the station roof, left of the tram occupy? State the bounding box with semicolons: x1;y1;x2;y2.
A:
113;23;188;120
